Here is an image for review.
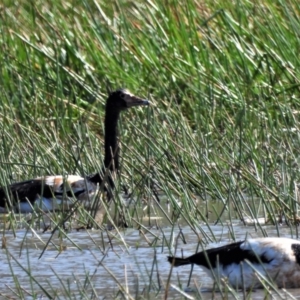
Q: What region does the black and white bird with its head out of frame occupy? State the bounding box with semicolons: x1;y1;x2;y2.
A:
168;238;300;289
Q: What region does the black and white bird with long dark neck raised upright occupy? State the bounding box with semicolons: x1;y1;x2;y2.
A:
0;89;149;213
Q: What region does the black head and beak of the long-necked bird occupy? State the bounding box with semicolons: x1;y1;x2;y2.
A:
106;89;149;111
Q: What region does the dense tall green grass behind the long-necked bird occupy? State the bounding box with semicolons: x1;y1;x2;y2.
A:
0;0;300;296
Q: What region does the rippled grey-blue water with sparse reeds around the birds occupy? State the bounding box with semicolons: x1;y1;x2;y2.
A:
0;203;300;299
